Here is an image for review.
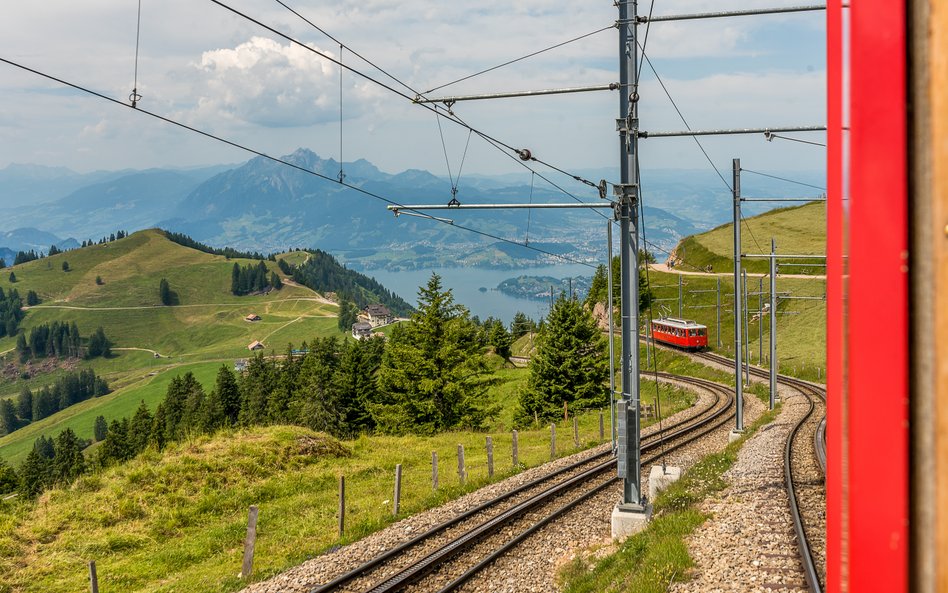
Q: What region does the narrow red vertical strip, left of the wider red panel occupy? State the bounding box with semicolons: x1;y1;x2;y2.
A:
826;0;848;593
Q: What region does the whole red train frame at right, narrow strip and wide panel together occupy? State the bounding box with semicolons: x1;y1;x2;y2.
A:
827;0;909;593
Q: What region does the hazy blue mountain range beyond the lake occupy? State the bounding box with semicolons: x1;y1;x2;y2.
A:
0;148;824;268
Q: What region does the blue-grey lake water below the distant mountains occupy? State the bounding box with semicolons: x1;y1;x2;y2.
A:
363;264;595;324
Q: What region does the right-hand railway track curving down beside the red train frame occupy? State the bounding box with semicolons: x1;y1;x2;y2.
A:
696;352;826;593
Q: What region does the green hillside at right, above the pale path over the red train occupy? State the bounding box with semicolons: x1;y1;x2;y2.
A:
673;202;826;275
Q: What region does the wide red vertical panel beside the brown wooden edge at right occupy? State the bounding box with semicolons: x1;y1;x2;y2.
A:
845;0;909;593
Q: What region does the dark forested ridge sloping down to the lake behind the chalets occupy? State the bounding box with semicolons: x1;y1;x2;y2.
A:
277;249;413;316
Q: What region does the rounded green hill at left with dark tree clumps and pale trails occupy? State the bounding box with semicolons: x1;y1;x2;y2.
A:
0;231;340;464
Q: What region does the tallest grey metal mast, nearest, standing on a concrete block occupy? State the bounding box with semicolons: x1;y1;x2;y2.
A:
615;0;645;510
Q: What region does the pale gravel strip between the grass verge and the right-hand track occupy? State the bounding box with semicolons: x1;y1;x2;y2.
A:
670;386;820;593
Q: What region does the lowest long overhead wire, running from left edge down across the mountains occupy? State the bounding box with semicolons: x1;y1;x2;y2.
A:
0;57;596;269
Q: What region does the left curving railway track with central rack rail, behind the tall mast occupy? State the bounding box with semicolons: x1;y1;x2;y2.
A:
311;373;734;593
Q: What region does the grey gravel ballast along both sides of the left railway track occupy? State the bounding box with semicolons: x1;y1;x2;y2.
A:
244;380;764;593
